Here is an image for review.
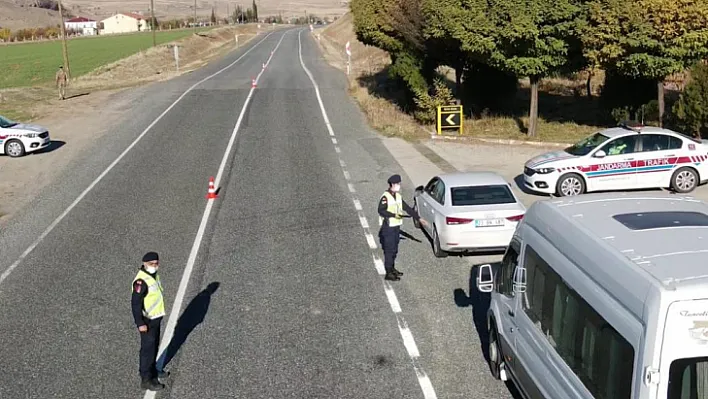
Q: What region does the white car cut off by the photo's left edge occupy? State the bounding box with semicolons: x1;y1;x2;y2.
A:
0;115;51;158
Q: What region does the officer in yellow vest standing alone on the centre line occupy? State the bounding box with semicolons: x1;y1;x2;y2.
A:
131;252;168;391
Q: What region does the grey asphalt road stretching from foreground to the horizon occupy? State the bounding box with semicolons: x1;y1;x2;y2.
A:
0;30;511;399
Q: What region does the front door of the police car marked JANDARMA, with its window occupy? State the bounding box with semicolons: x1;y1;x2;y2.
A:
586;134;639;191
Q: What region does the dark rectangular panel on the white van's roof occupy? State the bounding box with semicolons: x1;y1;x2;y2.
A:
612;211;708;230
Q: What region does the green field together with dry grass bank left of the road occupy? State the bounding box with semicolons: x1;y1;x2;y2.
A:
0;24;257;121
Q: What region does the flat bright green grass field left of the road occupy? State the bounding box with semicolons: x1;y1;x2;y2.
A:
0;28;210;89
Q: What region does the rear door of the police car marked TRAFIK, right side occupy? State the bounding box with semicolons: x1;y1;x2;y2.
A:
637;133;683;188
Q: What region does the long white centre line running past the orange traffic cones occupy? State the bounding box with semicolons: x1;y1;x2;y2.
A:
144;32;288;399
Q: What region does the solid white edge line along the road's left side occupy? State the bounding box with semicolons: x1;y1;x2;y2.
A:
0;32;273;284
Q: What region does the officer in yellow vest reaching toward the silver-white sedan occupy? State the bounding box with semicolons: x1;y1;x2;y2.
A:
379;175;428;281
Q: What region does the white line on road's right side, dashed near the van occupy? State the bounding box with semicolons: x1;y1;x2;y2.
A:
297;30;437;399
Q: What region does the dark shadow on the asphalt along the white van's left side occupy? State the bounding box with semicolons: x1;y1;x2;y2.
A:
453;262;521;399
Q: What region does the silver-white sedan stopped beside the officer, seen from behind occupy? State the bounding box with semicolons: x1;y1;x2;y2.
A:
413;172;526;258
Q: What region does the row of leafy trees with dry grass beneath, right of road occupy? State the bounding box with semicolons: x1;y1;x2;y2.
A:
320;0;708;142
